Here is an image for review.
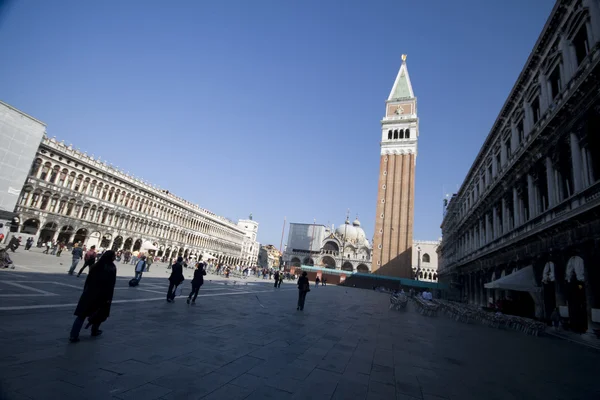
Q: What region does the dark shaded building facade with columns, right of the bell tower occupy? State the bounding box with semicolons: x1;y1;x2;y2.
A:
439;0;600;331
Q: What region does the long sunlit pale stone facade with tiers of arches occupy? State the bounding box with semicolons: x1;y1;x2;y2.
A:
16;137;244;264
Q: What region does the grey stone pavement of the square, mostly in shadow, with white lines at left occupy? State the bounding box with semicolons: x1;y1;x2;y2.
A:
0;251;600;400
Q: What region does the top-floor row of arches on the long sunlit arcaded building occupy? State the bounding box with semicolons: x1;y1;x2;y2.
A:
30;158;235;239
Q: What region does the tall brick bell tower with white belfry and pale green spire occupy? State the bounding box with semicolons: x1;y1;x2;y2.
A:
372;55;419;278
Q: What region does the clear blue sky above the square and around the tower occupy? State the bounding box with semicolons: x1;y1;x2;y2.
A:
0;0;554;246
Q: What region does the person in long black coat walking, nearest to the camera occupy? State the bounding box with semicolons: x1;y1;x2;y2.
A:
69;250;117;342
